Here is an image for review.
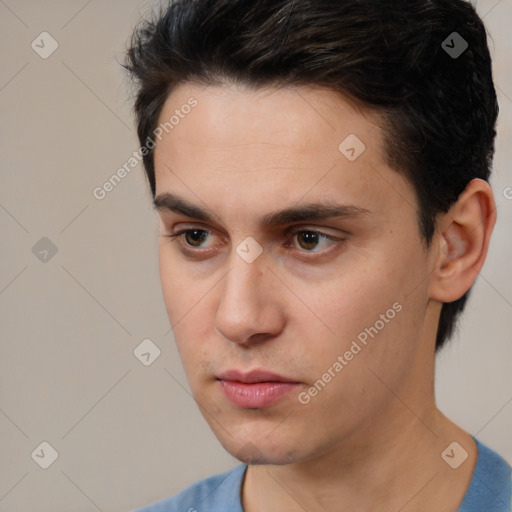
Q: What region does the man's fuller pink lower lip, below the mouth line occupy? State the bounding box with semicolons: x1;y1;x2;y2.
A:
219;380;298;409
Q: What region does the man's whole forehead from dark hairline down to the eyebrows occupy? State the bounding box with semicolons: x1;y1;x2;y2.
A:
154;83;413;227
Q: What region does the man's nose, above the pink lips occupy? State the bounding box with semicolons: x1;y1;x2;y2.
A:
215;252;284;345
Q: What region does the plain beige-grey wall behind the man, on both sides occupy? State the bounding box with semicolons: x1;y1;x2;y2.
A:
0;0;512;512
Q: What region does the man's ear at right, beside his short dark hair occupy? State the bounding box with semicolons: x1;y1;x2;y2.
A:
429;179;496;302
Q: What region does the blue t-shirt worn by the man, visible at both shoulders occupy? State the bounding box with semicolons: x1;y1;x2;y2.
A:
138;439;512;512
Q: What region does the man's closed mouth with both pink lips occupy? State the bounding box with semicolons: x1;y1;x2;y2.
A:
217;370;300;409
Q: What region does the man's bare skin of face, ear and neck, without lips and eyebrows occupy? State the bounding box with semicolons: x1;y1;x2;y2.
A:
155;83;496;512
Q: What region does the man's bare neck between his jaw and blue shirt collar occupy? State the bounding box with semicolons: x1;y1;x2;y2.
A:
242;409;476;512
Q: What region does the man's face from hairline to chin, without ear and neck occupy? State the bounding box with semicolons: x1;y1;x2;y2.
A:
155;84;435;464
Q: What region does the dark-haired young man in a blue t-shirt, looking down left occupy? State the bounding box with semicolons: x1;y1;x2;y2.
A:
125;0;510;512
